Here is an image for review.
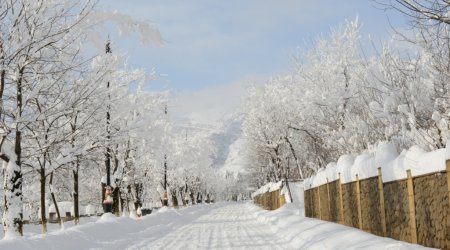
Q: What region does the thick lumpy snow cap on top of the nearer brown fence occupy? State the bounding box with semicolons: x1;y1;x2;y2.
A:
304;141;450;189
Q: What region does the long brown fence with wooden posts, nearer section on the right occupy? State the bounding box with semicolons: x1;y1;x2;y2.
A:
305;161;450;249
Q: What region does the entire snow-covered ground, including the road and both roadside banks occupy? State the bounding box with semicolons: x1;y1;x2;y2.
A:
0;203;430;249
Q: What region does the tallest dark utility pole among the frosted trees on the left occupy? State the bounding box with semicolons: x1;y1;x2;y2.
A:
103;37;113;213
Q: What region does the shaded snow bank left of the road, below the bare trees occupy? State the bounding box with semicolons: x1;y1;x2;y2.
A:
0;206;214;250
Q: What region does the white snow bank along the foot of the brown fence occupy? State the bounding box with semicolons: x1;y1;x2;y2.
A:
250;204;427;250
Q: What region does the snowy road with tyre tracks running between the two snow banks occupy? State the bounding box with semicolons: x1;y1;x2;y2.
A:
129;204;284;249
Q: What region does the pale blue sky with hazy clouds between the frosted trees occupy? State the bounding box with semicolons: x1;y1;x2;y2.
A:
99;0;406;126
